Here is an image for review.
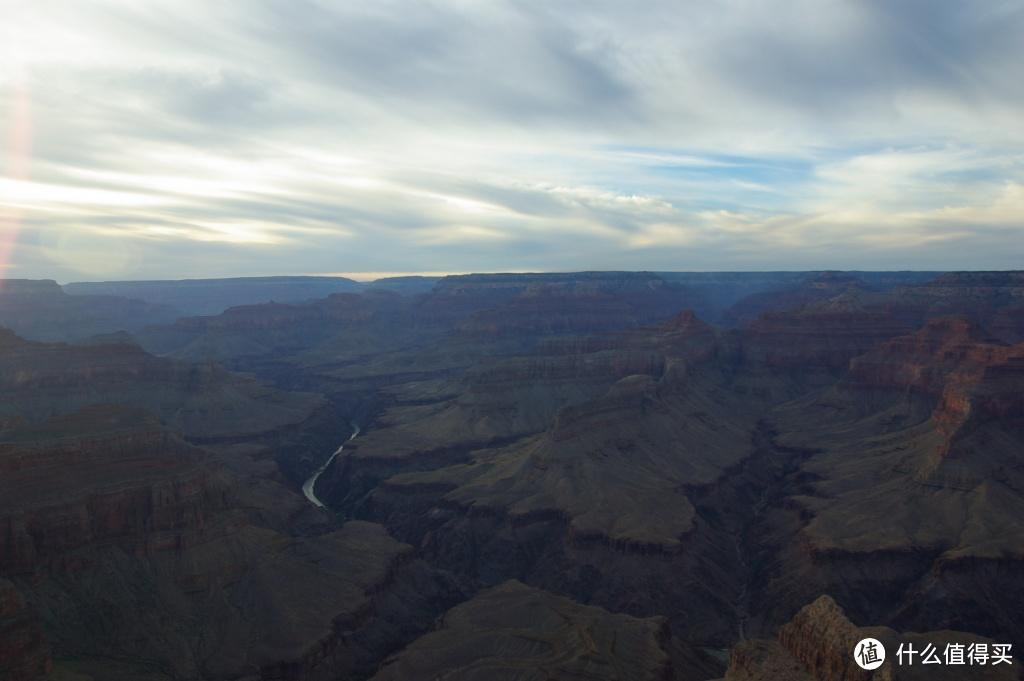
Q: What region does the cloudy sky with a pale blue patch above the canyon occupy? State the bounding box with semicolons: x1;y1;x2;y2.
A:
0;0;1024;282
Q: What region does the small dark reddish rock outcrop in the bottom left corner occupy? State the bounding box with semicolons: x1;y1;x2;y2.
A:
0;579;53;681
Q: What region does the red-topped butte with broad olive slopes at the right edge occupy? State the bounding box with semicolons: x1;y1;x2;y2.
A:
769;320;1024;642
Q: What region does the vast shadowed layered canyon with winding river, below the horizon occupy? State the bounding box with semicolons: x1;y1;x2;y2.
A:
0;272;1024;681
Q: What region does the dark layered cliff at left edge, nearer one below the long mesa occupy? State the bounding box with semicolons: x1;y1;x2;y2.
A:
0;407;226;574
